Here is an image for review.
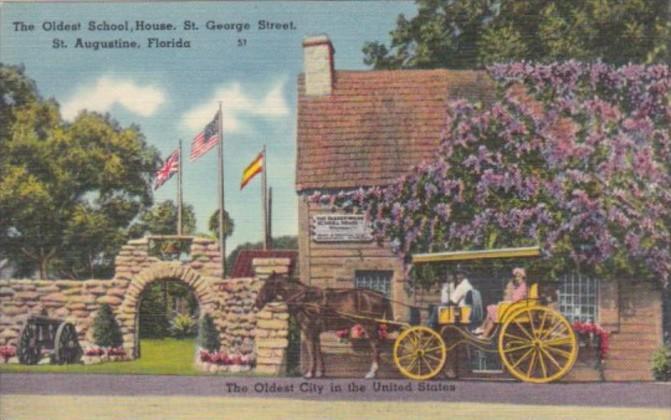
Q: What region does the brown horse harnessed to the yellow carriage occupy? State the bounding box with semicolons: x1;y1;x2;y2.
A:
254;273;393;378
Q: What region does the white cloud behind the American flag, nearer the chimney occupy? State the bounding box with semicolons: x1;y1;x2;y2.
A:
182;81;289;133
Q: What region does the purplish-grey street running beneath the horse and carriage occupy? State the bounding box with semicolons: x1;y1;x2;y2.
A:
0;373;671;410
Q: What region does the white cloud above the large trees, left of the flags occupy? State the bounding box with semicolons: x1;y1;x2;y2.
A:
61;76;166;120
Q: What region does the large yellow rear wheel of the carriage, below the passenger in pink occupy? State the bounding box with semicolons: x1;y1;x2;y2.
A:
499;306;578;384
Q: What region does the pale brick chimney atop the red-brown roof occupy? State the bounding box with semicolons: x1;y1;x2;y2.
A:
303;35;335;96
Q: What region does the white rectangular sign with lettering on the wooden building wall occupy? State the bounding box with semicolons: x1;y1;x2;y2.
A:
310;214;373;242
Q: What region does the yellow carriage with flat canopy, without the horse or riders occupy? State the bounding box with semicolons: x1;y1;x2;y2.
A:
393;247;578;383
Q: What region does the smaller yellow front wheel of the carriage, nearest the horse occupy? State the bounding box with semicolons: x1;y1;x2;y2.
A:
394;326;447;381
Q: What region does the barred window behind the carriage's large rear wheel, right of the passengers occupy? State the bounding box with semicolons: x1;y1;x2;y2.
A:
559;272;599;322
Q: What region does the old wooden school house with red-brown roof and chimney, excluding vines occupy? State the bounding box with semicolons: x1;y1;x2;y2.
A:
296;36;663;381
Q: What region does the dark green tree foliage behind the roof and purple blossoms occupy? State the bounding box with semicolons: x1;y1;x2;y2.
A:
363;0;671;69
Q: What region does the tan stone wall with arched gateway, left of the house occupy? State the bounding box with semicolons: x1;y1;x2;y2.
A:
0;238;290;373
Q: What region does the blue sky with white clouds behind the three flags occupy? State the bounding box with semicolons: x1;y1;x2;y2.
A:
0;1;416;252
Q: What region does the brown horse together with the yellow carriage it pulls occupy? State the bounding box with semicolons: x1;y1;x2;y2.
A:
255;247;578;383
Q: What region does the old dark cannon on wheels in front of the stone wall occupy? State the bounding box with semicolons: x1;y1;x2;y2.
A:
17;316;82;365
